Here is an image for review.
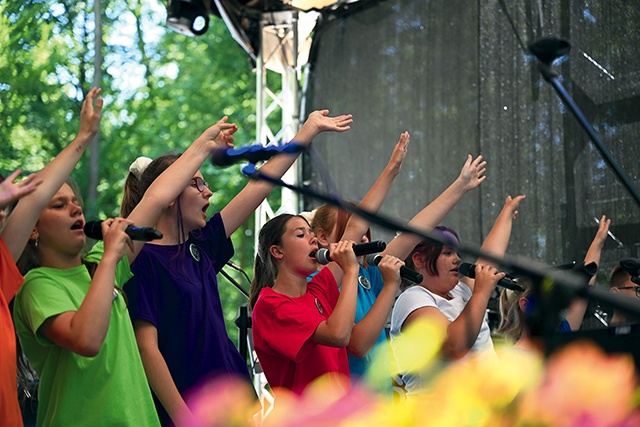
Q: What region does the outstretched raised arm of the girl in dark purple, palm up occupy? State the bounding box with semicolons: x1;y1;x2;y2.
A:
220;110;353;237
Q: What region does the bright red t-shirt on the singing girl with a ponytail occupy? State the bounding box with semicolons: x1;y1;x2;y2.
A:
252;268;349;394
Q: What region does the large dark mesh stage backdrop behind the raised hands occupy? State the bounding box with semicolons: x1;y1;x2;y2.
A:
303;0;640;298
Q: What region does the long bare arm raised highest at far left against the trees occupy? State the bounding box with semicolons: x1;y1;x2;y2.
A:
2;88;103;260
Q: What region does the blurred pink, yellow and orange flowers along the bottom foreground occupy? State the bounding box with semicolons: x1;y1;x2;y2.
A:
180;322;640;427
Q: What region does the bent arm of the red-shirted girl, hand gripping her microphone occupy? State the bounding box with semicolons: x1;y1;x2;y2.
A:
312;240;358;347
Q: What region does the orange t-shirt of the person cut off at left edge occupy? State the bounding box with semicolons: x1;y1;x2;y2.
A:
0;237;24;426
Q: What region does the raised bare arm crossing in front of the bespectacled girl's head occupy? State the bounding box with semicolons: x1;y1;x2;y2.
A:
127;116;238;262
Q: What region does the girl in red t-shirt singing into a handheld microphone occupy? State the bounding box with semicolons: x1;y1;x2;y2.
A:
251;214;404;394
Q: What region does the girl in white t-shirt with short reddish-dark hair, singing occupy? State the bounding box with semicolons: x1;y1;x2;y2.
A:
390;196;524;394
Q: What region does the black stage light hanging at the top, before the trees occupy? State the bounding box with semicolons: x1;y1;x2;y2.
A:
167;0;209;37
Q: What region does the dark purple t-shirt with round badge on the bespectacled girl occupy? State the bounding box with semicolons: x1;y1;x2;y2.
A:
124;213;251;424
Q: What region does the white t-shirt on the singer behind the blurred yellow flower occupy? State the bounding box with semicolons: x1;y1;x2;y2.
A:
390;282;495;394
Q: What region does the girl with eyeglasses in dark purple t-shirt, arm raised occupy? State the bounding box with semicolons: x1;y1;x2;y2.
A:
121;110;352;425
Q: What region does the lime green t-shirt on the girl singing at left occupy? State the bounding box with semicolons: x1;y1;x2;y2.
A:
14;244;159;426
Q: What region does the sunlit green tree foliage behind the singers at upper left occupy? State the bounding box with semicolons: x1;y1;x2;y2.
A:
0;0;256;341
